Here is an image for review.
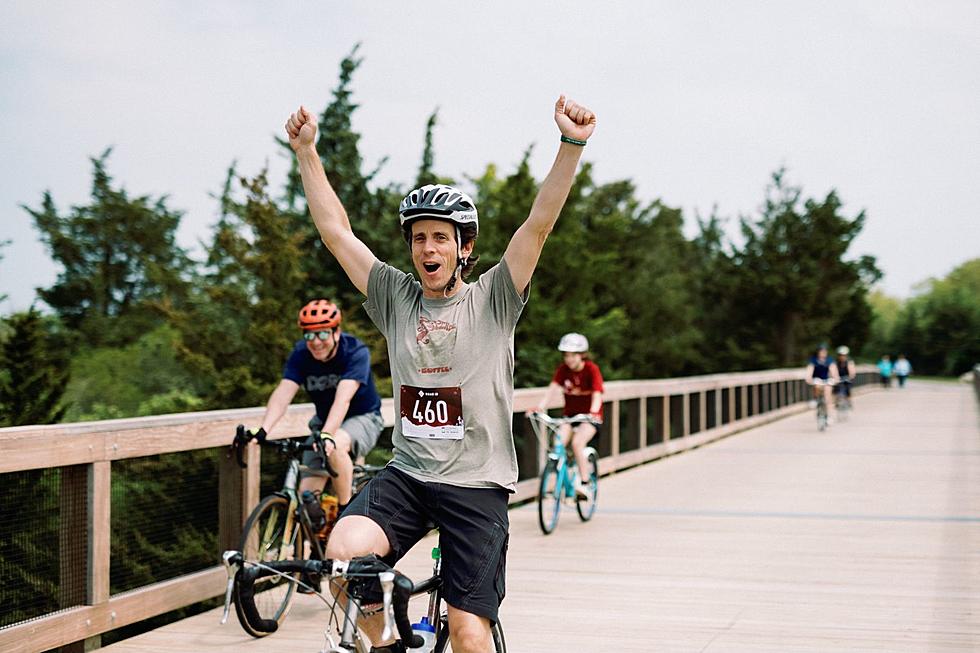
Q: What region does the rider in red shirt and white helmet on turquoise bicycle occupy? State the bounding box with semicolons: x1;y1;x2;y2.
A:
537;333;602;497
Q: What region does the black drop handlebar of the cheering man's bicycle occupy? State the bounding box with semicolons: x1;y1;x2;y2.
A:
224;551;424;648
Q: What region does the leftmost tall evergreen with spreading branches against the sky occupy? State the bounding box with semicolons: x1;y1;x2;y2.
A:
24;150;189;345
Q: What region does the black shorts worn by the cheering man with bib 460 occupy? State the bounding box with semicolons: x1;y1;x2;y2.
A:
344;466;510;623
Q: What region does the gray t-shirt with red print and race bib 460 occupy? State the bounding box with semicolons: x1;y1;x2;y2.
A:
364;261;527;491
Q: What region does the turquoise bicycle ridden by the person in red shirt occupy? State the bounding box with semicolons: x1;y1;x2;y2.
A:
527;412;599;535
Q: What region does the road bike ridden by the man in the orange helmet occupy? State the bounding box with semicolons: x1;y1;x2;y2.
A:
232;424;383;637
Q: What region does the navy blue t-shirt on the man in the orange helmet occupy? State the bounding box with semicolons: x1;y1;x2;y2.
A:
282;333;381;420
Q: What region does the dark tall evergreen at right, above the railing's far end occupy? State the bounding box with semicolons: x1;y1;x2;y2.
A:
727;171;881;368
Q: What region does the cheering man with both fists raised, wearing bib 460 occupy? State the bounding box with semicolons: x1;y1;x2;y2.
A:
286;96;596;653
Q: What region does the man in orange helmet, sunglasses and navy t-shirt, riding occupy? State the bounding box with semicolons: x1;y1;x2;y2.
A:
255;299;384;510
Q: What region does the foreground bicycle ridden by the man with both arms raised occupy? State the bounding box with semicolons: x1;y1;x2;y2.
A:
221;547;507;653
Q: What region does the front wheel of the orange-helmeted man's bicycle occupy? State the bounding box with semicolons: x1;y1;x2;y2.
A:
233;494;303;637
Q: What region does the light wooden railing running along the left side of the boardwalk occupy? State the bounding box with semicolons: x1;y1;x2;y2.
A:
0;366;877;653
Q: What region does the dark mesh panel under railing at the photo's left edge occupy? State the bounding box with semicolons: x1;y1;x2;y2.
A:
0;467;87;628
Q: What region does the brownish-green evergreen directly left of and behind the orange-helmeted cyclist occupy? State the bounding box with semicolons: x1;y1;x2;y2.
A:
165;170;308;408
